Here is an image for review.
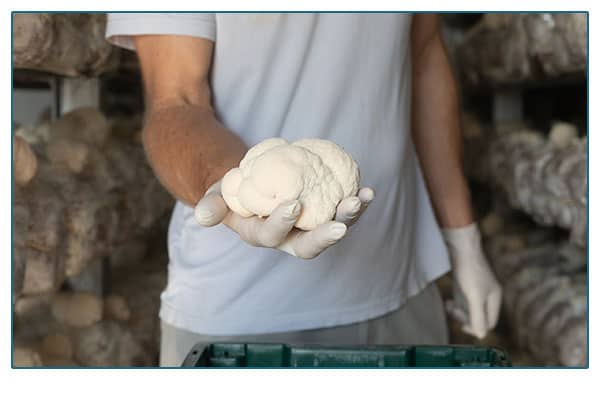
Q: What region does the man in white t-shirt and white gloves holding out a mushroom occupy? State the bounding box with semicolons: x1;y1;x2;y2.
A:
107;13;501;365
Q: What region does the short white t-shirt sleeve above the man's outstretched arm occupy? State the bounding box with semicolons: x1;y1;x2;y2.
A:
106;13;216;50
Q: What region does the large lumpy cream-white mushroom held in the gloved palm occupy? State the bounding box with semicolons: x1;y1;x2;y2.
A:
221;138;360;230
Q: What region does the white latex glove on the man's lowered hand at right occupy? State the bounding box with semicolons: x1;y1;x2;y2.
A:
442;223;502;339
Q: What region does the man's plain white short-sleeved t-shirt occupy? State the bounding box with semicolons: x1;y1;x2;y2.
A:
107;14;449;335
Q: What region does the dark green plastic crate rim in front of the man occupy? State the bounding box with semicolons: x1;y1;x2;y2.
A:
182;343;511;368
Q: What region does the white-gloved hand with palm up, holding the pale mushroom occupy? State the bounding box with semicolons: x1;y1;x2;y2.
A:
194;181;375;259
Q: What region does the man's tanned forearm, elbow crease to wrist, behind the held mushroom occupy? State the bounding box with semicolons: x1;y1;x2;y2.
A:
143;104;246;206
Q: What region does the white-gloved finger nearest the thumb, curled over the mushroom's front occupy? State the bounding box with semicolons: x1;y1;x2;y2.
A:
257;200;302;247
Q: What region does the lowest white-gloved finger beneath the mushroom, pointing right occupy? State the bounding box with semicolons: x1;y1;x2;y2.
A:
284;221;348;259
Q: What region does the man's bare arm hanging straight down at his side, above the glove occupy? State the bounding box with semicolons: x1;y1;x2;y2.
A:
412;26;473;228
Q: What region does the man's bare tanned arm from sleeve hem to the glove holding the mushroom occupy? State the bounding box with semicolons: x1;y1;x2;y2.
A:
134;35;246;206
